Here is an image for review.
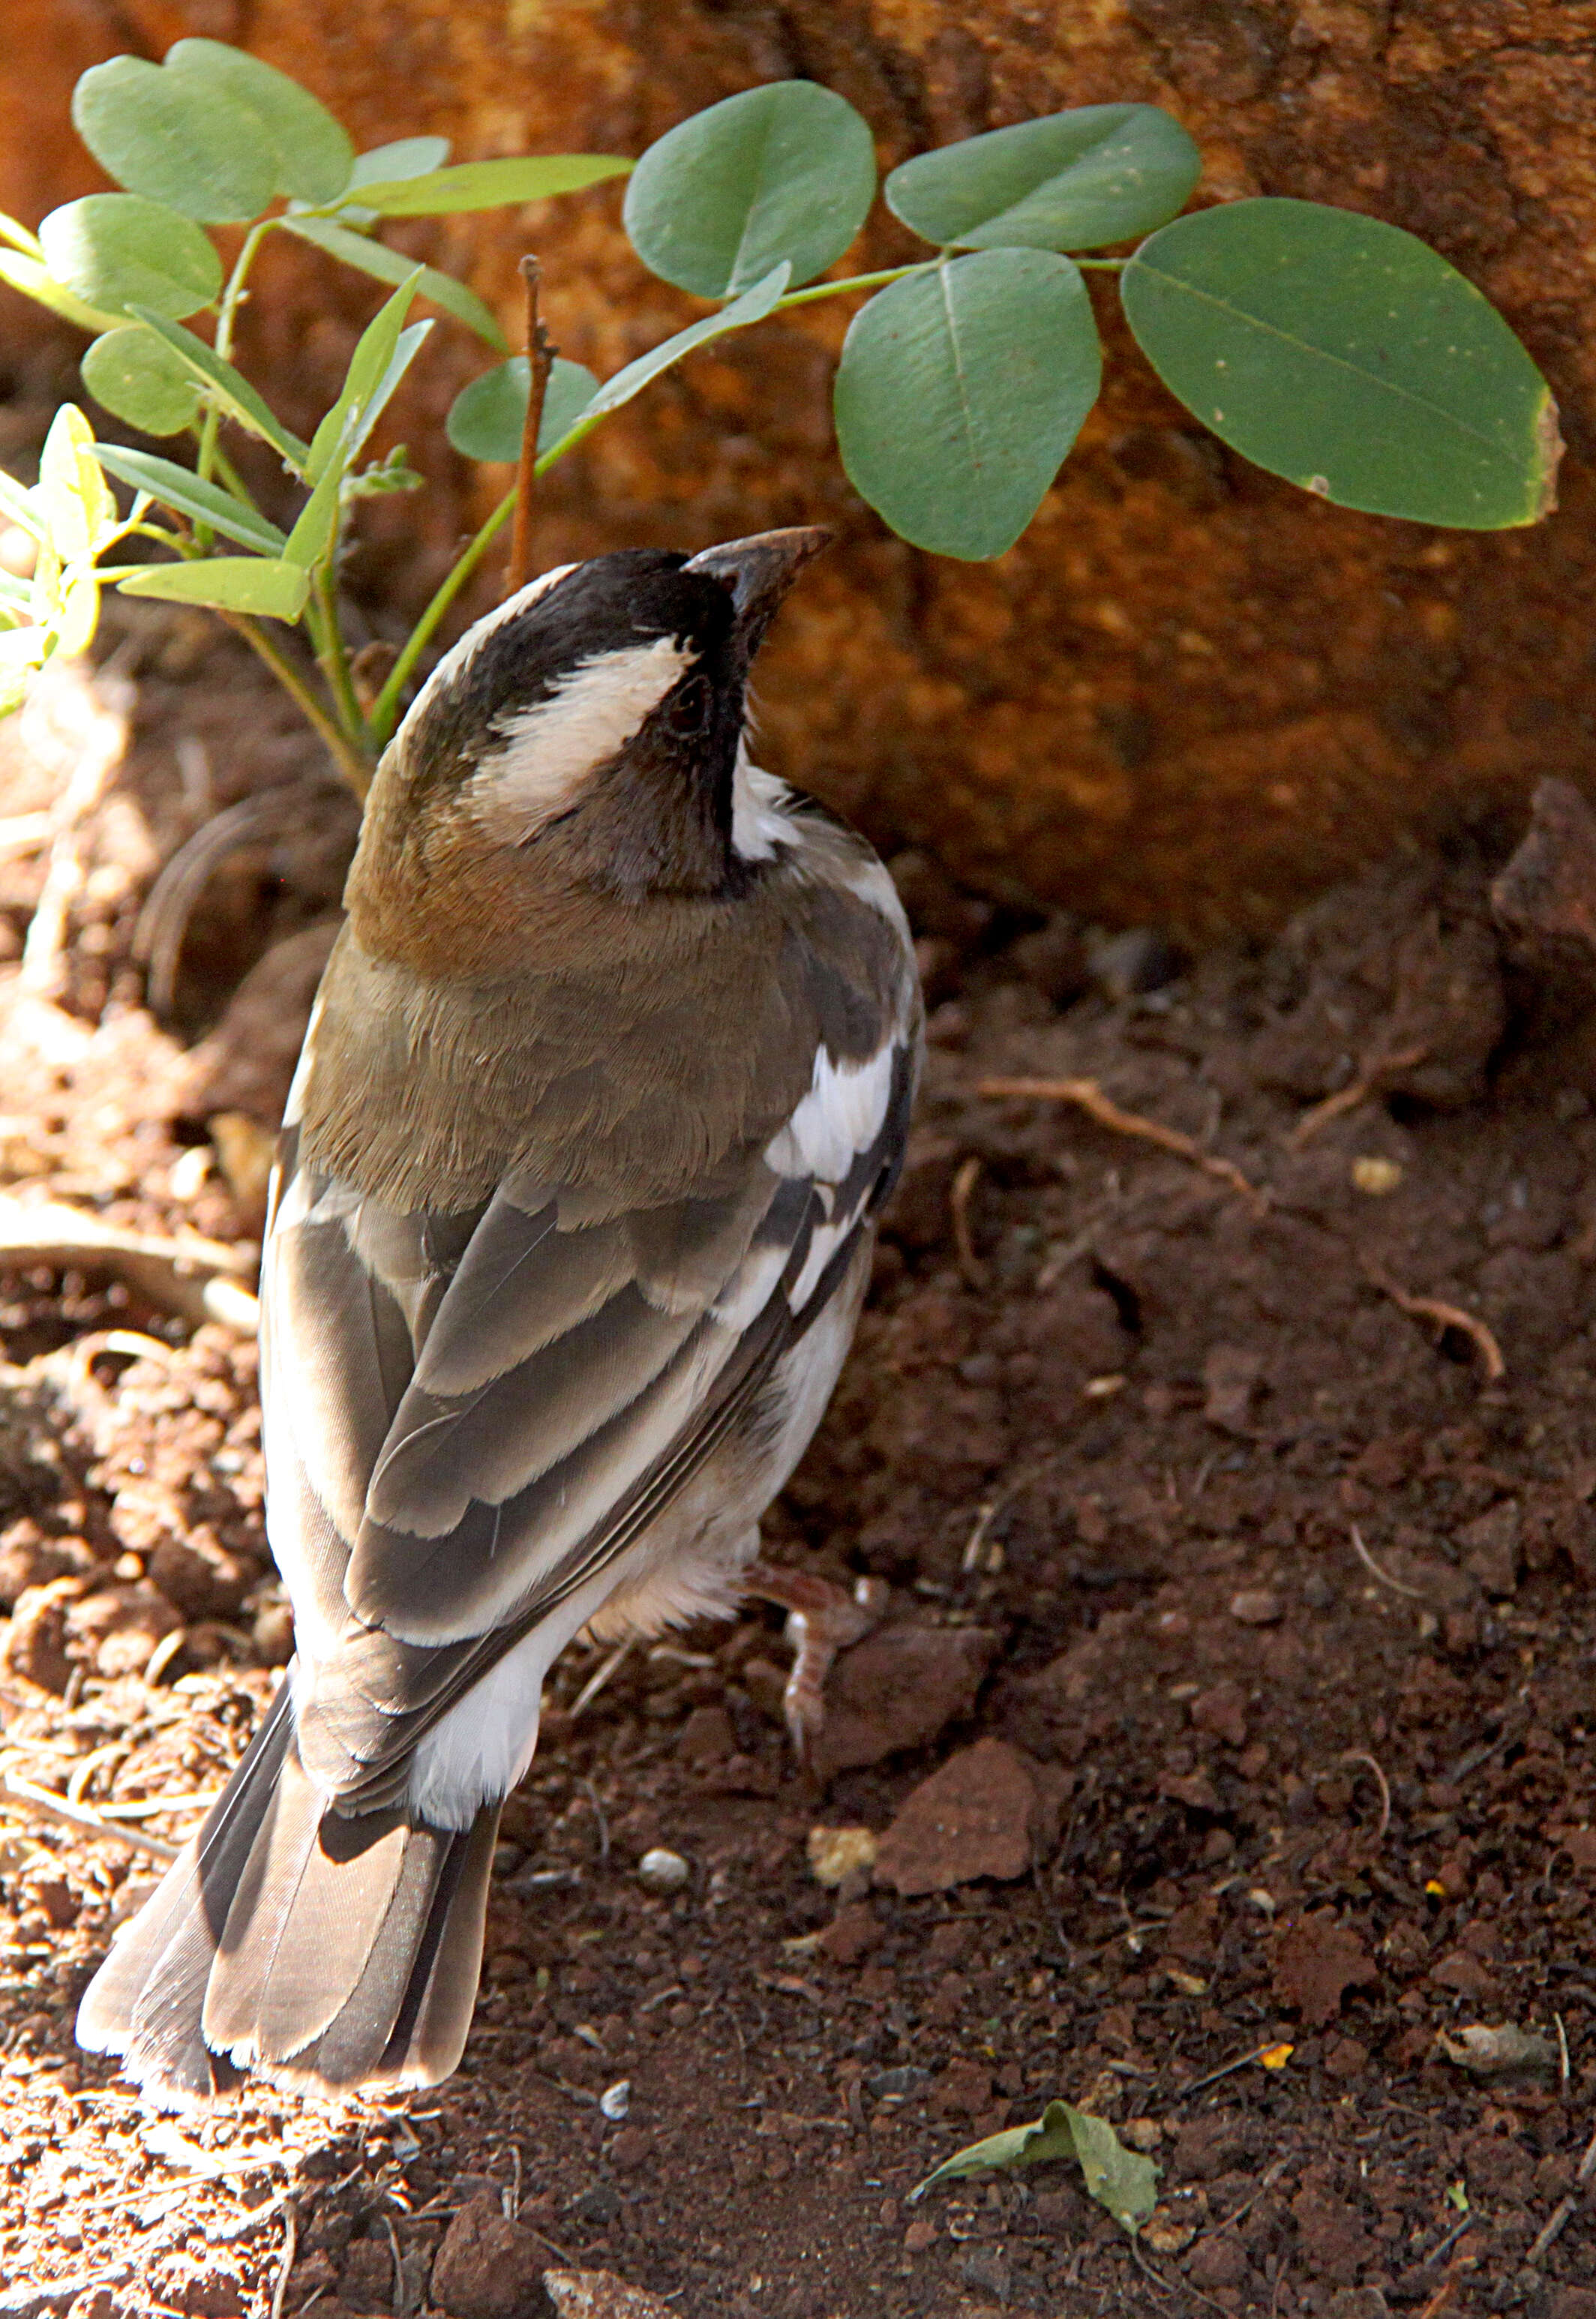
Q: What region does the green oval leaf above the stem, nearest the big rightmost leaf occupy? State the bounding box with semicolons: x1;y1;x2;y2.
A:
881;104;1202;250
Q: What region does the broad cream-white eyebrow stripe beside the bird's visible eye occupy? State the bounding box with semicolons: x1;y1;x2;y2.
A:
466;635;692;835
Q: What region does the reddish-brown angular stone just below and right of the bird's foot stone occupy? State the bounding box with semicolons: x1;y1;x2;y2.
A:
874;1739;1046;1894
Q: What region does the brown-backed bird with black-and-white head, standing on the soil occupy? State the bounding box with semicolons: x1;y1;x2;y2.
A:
76;526;923;2110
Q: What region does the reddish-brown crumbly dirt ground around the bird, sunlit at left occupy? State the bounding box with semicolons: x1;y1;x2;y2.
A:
0;608;1596;2319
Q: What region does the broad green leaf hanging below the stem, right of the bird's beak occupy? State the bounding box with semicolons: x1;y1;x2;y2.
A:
835;250;1102;559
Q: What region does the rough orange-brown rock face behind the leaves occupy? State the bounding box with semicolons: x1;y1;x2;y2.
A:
0;0;1596;937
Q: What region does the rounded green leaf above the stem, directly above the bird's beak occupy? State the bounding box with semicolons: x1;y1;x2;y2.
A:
624;81;874;297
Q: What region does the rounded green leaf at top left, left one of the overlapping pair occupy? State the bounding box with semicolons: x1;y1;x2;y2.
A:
72;56;276;225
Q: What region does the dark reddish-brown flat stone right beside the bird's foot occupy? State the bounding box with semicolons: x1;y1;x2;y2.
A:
814;1625;998;1779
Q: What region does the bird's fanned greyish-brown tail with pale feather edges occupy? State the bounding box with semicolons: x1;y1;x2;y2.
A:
79;1686;499;2108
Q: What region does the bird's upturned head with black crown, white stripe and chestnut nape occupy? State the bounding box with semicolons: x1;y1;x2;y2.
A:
348;529;828;964
